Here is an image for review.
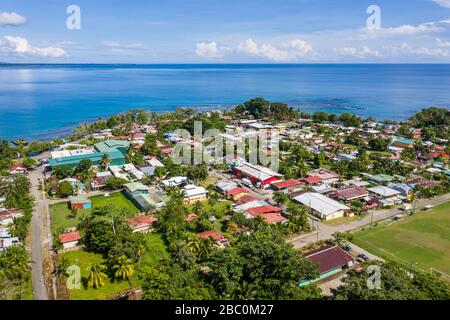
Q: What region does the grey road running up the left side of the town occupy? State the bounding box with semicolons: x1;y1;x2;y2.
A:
30;167;48;300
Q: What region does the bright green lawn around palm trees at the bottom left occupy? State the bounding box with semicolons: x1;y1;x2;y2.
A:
63;250;132;300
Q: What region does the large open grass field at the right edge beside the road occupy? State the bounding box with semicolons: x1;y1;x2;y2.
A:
352;202;450;275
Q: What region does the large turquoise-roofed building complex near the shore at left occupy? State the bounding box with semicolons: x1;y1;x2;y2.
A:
48;140;131;168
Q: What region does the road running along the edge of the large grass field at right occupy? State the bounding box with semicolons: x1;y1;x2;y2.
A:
289;193;450;250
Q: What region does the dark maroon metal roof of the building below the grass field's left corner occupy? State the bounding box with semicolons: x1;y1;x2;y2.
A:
305;245;353;274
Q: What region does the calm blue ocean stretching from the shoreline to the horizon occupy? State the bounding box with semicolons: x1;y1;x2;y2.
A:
0;64;450;140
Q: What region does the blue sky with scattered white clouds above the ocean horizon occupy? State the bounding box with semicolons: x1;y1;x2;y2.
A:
0;0;450;63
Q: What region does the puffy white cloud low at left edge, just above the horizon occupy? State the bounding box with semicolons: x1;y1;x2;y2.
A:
0;36;67;58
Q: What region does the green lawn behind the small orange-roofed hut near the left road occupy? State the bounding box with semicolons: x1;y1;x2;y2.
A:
50;192;139;232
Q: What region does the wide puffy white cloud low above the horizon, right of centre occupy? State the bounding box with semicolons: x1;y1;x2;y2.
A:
237;39;313;61
